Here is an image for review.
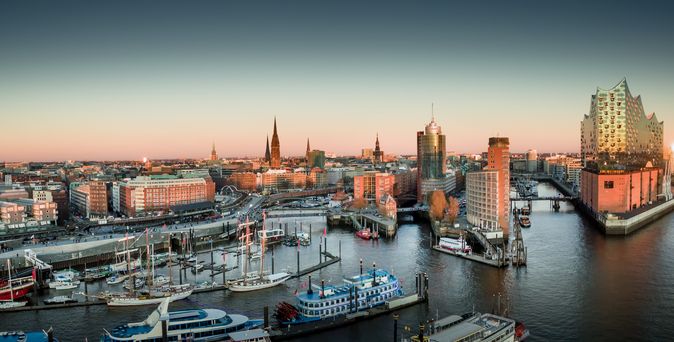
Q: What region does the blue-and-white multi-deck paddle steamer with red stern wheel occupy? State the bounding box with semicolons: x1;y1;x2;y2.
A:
275;268;404;326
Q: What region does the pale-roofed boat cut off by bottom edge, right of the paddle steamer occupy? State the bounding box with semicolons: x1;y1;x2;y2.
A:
412;312;522;342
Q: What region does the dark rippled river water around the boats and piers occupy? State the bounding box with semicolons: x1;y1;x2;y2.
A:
0;184;674;342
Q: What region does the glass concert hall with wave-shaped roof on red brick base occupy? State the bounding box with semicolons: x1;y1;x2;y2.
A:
580;79;669;214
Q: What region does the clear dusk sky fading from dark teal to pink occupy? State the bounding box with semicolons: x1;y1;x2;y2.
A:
0;0;674;161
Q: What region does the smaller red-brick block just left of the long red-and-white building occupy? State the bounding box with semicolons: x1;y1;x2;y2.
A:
70;181;108;218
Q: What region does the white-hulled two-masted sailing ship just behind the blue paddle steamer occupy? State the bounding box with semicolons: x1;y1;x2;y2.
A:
227;211;290;292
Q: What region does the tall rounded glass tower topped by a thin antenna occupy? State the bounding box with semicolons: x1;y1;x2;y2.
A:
417;117;456;202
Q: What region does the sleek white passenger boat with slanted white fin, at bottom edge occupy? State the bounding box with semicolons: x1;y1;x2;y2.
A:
101;300;264;342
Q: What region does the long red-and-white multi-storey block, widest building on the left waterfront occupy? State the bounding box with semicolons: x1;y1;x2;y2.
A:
119;175;215;217
